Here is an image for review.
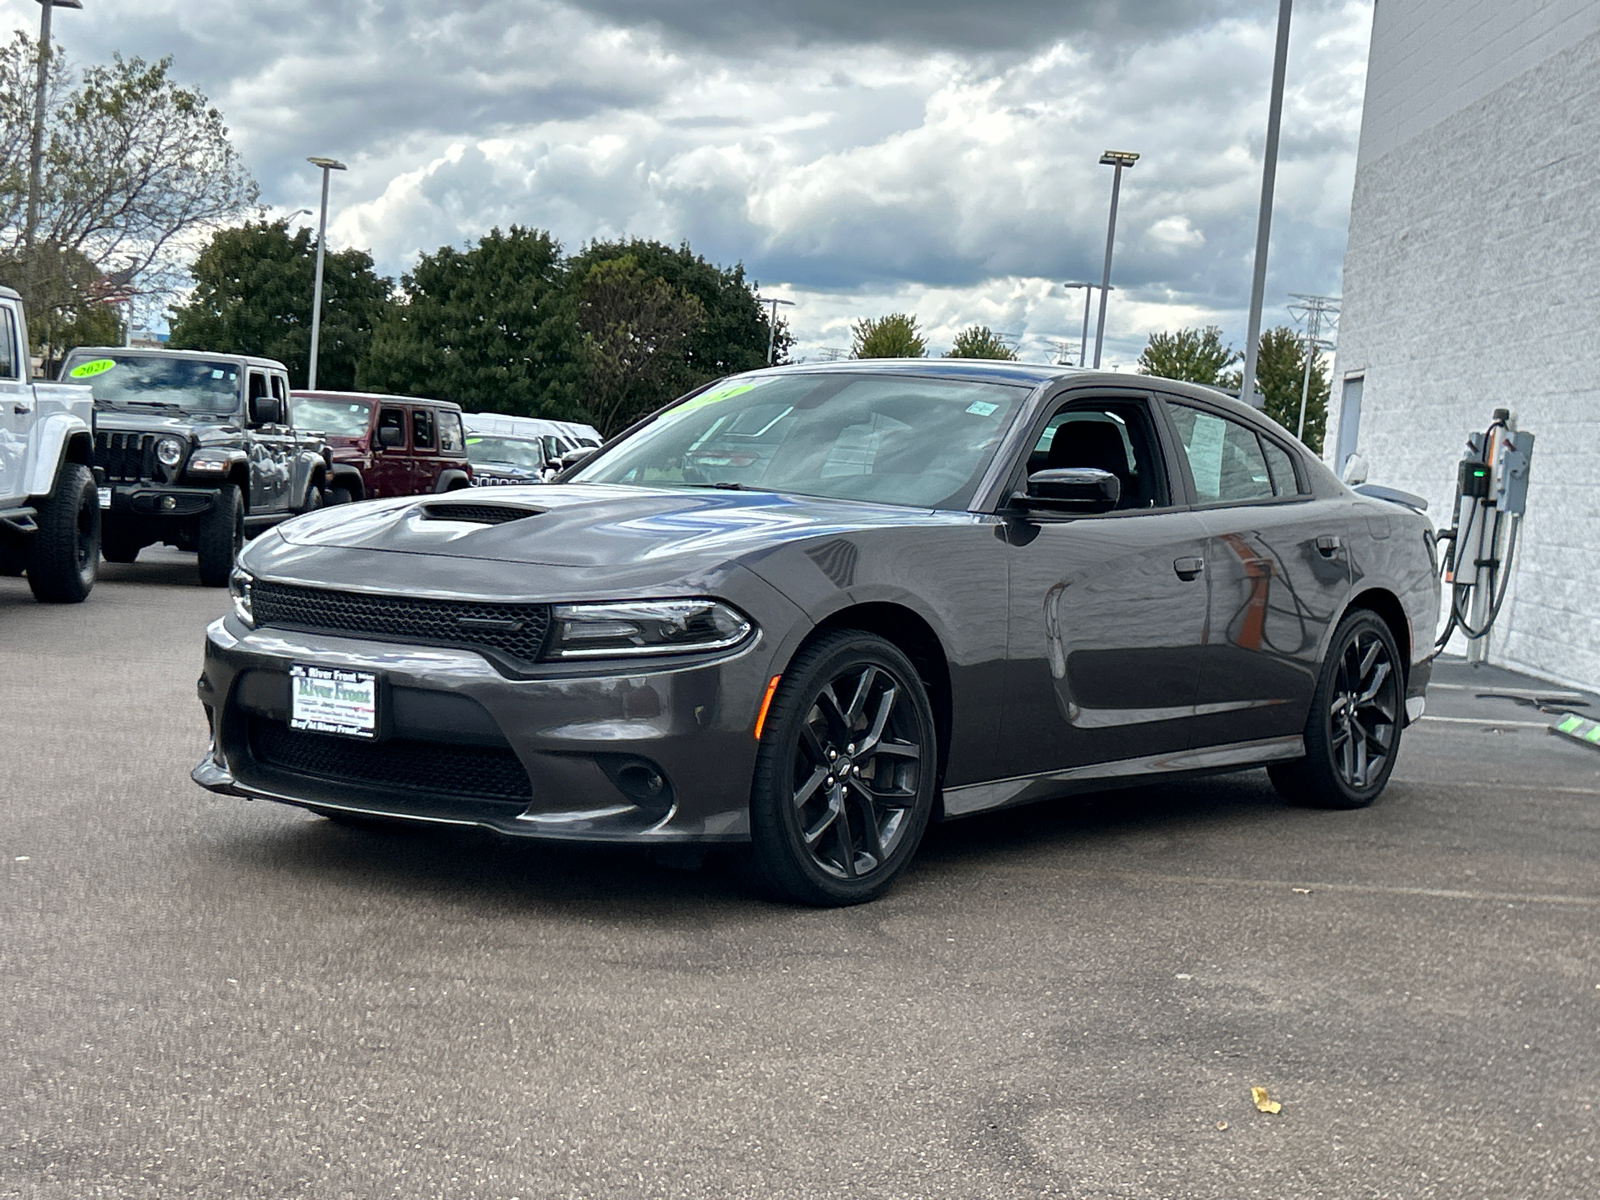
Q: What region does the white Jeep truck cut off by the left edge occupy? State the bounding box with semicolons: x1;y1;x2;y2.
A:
0;288;101;603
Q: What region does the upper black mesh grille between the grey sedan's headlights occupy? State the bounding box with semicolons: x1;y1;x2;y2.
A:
250;579;550;666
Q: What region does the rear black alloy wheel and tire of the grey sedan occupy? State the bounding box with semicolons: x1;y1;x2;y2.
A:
1269;610;1405;808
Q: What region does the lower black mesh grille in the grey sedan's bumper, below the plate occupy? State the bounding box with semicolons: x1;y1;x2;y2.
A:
250;717;533;805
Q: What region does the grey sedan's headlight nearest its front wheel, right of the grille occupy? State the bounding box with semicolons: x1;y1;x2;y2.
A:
546;600;755;659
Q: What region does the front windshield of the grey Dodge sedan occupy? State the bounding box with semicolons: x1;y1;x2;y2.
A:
573;373;1027;509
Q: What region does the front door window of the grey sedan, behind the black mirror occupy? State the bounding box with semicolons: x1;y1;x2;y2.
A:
1027;400;1171;512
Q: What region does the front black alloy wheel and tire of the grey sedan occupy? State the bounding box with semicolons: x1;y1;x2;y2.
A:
750;630;939;906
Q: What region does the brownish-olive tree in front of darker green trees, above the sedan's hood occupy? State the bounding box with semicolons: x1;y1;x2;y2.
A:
578;254;706;437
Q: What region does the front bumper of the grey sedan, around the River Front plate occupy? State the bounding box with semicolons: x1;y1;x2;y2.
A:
192;618;771;845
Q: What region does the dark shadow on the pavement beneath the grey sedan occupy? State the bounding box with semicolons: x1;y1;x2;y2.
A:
209;771;1282;923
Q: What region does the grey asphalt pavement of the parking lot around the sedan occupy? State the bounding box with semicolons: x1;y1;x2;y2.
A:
0;550;1600;1200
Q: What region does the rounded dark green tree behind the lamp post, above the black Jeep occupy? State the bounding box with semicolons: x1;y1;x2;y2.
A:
170;221;394;390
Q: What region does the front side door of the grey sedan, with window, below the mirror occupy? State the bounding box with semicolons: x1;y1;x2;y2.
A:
1000;392;1206;776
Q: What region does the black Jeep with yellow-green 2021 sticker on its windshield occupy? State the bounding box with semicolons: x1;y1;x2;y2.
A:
61;346;330;587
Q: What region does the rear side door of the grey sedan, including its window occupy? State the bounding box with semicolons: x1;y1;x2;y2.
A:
1165;397;1350;747
